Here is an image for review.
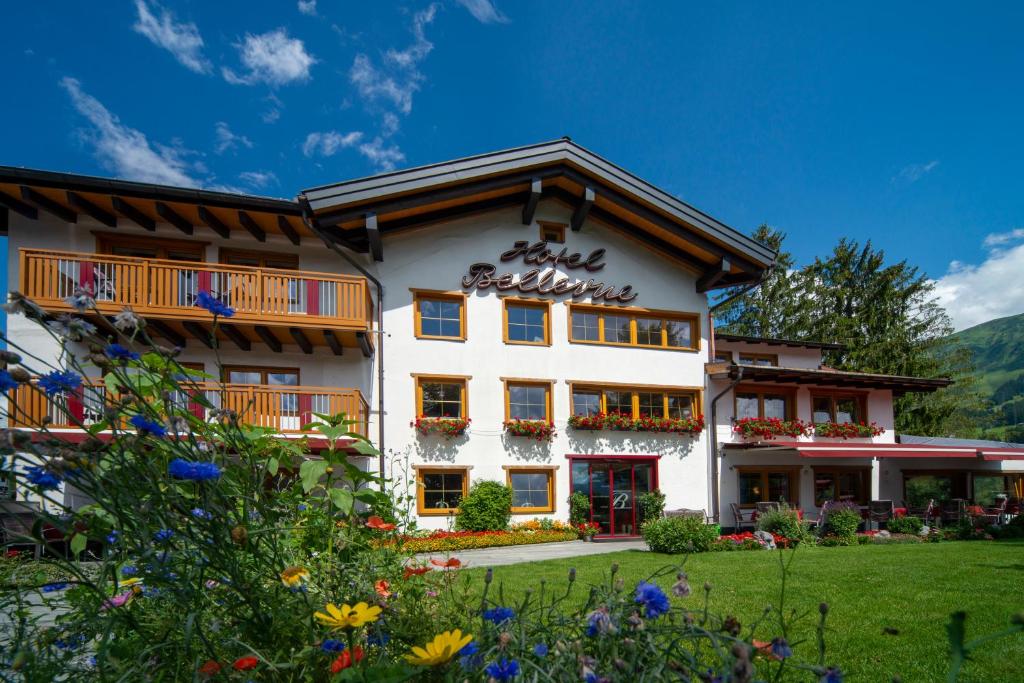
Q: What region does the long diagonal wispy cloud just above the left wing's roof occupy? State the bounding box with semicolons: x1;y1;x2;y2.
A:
60;77;201;187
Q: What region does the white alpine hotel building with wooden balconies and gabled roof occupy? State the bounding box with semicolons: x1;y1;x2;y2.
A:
0;139;1024;537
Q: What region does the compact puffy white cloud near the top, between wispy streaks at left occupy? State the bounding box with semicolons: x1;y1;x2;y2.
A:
221;29;316;85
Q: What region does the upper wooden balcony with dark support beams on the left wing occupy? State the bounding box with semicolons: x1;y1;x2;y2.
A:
19;249;374;355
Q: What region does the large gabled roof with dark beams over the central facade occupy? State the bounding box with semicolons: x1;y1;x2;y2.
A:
299;138;775;291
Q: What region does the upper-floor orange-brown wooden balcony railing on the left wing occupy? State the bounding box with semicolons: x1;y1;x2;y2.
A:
19;249;373;331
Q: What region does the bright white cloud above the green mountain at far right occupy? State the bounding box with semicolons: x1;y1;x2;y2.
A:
935;228;1024;330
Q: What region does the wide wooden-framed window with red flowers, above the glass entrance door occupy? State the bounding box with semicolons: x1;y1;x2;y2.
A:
570;382;700;420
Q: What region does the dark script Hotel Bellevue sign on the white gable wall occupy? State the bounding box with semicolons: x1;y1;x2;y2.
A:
462;240;637;303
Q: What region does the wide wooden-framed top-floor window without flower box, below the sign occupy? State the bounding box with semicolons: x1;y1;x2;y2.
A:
568;303;700;351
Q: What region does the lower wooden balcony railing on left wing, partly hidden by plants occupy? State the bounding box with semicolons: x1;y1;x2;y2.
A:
8;380;370;436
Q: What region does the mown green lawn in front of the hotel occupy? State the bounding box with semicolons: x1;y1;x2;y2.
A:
469;541;1024;683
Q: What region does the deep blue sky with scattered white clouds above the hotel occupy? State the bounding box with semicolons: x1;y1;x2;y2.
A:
0;0;1024;328
